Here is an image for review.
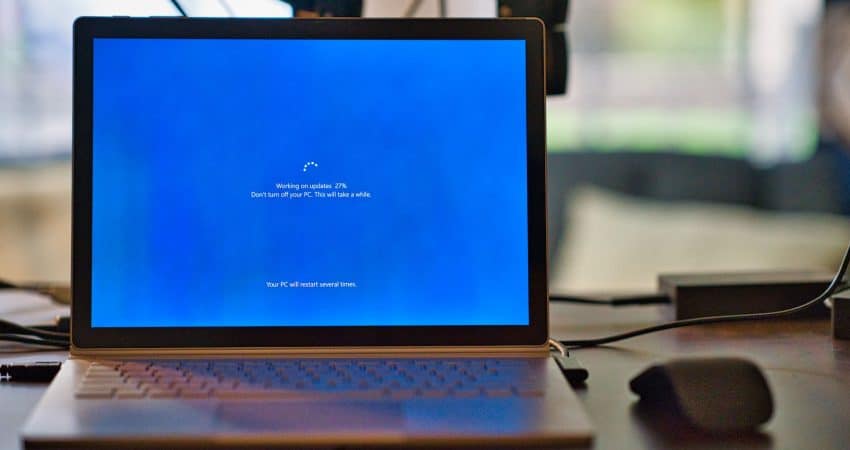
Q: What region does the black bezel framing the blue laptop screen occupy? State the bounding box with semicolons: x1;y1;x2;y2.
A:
71;17;548;349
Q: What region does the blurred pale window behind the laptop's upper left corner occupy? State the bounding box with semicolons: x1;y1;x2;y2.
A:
0;0;292;162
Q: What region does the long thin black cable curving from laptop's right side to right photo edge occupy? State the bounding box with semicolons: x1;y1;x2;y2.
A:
560;243;850;347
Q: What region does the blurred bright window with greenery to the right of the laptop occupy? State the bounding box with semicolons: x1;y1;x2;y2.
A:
548;0;821;163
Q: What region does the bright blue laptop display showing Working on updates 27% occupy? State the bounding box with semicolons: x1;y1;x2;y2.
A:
91;38;529;327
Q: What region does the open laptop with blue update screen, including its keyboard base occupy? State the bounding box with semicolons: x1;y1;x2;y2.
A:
22;18;592;448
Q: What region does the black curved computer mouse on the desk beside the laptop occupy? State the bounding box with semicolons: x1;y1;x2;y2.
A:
629;358;773;432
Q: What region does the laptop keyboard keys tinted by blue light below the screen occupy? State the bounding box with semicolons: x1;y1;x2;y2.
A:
75;359;543;399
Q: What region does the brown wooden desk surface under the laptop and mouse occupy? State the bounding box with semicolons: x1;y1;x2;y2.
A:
0;298;850;450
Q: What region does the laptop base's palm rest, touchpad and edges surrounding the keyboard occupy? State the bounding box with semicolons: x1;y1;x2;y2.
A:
22;357;592;449
